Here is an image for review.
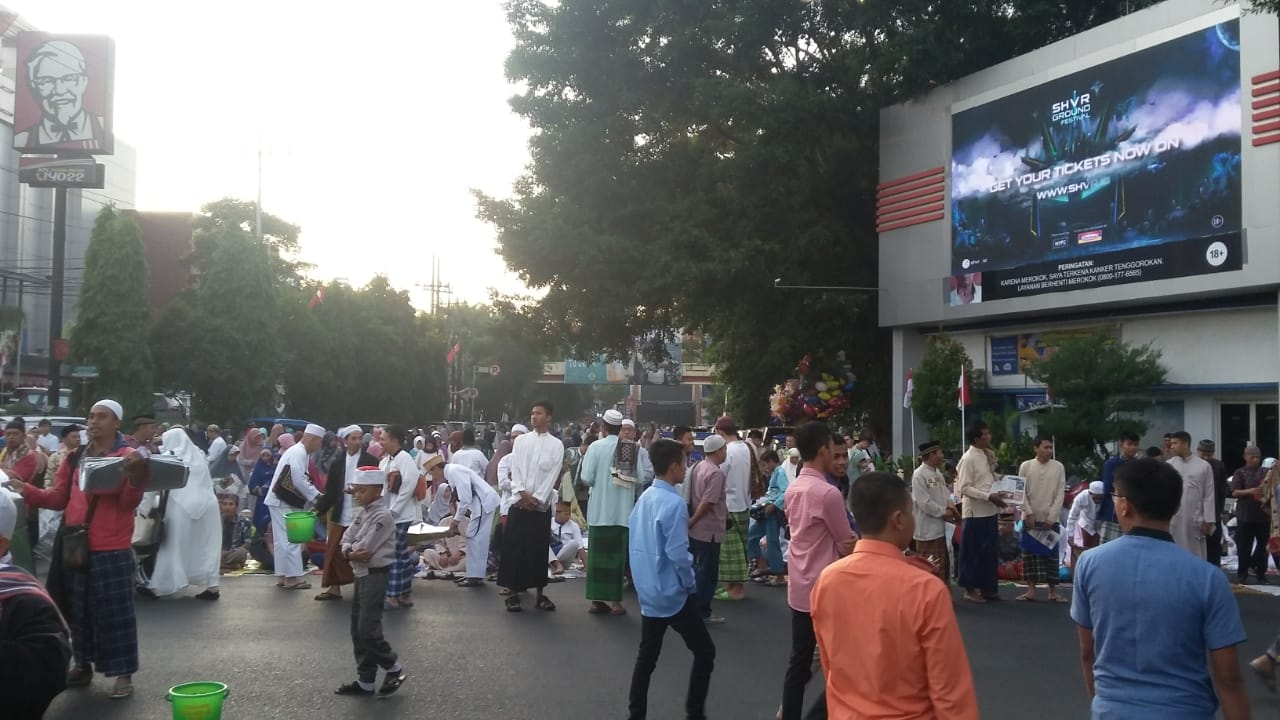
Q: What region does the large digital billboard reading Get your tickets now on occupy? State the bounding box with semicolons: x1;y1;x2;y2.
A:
943;19;1243;305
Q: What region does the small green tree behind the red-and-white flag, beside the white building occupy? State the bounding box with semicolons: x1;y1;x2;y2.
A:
911;333;977;447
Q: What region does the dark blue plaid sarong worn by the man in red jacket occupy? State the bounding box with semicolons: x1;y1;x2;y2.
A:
65;550;138;678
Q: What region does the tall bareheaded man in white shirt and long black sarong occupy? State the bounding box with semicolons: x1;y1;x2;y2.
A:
498;401;564;612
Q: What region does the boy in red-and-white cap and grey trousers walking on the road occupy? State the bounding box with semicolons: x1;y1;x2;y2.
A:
334;468;408;696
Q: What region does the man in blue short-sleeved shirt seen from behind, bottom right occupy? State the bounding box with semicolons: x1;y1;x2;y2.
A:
1071;459;1249;720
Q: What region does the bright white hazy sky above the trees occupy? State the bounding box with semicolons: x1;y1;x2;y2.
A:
24;0;530;309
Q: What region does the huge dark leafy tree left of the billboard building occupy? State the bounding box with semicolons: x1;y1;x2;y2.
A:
477;0;1152;436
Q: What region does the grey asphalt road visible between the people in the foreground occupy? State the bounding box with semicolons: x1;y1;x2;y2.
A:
47;575;1280;720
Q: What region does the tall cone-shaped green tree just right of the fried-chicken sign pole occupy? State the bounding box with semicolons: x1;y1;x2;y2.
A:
69;205;154;414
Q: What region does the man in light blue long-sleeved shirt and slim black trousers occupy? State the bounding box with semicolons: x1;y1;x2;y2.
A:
630;439;716;720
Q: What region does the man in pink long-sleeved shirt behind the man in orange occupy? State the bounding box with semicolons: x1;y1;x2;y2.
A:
782;423;854;720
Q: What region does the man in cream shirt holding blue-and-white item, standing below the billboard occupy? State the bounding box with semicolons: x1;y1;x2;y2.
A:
1018;436;1066;602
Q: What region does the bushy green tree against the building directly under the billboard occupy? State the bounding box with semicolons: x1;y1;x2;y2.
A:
1027;328;1167;477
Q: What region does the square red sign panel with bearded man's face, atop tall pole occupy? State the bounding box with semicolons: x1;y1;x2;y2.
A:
13;32;115;155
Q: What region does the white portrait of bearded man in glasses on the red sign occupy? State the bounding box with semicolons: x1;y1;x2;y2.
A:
13;40;106;152
